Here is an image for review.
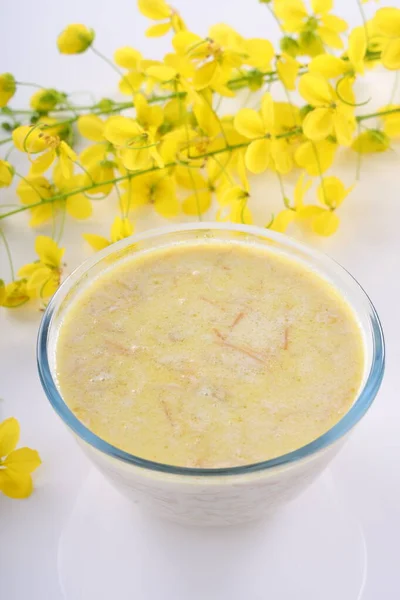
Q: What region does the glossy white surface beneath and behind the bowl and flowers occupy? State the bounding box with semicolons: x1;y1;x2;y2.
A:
0;0;400;600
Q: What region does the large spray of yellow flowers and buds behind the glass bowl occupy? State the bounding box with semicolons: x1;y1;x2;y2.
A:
0;0;400;308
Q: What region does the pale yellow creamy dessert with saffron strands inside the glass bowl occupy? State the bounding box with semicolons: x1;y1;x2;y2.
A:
56;241;364;468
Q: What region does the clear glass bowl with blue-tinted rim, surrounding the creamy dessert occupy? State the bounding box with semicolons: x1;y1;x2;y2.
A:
37;223;384;525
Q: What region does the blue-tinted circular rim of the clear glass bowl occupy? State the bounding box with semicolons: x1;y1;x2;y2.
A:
37;222;385;477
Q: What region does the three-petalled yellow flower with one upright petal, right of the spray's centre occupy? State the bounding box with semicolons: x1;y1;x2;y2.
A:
234;93;292;173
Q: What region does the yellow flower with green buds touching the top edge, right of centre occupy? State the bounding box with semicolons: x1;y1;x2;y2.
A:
274;0;348;53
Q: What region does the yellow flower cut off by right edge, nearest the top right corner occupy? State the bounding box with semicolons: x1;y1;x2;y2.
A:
374;8;400;71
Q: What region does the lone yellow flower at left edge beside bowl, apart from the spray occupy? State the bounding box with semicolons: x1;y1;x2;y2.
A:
0;417;42;498
